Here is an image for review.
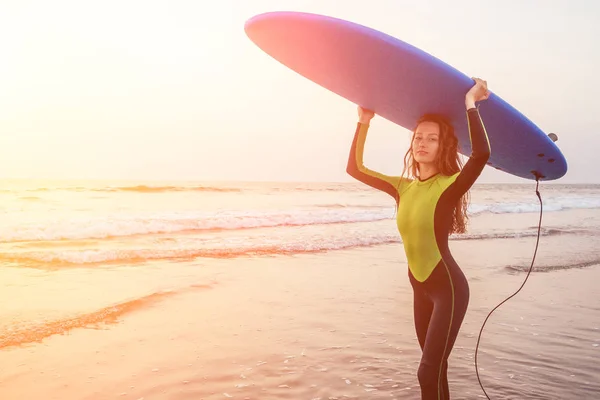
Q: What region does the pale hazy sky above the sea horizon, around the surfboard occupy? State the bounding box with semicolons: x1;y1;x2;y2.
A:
0;0;600;183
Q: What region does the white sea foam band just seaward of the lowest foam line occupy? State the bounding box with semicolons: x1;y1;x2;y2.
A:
0;197;600;242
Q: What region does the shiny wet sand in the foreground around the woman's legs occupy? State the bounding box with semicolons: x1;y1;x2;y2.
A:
0;205;600;400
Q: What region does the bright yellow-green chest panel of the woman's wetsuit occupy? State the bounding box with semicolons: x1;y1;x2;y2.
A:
396;174;458;282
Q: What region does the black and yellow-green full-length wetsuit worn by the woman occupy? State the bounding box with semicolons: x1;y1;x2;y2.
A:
347;108;490;400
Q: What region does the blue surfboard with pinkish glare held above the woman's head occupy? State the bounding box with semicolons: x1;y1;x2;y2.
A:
244;11;567;180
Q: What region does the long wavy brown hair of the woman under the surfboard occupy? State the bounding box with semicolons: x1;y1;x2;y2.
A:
401;114;470;234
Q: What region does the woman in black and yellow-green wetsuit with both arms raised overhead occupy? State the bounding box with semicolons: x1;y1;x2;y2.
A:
347;78;490;400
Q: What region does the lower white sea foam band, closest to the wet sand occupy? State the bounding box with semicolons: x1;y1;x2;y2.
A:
0;228;577;266
